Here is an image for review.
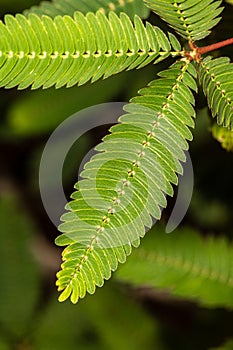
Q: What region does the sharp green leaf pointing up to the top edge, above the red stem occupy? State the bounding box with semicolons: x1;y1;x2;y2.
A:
145;0;223;41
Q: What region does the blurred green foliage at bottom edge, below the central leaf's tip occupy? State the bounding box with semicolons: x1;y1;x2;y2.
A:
34;283;160;350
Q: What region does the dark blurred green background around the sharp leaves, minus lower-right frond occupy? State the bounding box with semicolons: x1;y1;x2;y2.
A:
0;0;233;350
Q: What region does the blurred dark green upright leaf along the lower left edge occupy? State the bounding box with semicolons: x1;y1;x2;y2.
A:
0;191;39;336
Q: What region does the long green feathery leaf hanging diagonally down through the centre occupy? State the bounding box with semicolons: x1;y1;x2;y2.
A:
56;61;196;303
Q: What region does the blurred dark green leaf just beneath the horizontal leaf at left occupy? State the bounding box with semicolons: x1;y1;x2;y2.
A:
7;75;126;136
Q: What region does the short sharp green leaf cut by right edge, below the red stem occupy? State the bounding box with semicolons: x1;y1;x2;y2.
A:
199;56;233;130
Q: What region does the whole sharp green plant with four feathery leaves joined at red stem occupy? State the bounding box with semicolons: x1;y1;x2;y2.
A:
0;0;233;303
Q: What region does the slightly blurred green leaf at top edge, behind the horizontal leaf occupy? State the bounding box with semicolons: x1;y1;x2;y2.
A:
24;0;149;18
